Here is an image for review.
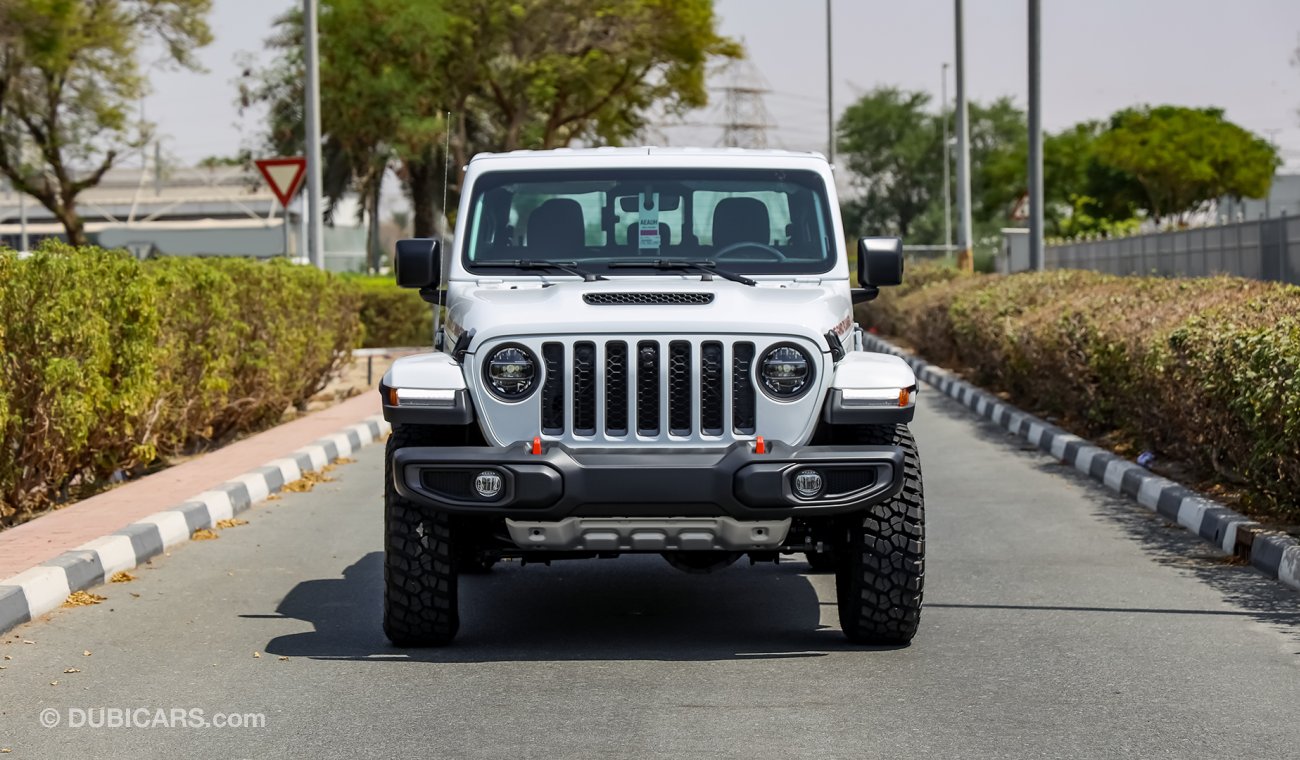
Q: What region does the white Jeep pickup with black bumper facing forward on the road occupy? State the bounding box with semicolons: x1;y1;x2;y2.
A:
380;148;924;647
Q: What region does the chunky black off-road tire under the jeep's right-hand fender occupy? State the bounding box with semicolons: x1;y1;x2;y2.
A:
835;425;926;646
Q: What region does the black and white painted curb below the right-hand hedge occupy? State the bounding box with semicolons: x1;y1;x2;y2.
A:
865;334;1300;590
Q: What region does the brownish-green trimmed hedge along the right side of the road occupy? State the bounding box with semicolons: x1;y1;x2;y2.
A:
859;268;1300;518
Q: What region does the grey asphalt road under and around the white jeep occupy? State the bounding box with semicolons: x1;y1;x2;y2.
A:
0;391;1300;759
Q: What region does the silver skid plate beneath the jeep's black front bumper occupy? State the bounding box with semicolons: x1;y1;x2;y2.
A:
506;517;790;552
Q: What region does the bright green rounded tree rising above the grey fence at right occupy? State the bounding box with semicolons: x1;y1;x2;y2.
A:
1095;105;1282;221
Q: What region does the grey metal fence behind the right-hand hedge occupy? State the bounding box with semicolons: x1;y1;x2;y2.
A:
1044;217;1300;285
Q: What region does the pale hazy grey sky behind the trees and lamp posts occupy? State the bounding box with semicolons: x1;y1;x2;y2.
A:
144;0;1300;171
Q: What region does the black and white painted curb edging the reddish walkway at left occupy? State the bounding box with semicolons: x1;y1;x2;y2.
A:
0;414;389;633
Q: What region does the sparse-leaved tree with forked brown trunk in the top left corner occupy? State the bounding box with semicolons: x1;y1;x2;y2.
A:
0;0;211;246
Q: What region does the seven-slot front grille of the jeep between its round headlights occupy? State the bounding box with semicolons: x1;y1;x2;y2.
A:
541;339;758;438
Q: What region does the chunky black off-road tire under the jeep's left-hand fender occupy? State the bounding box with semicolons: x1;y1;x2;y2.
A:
384;425;460;647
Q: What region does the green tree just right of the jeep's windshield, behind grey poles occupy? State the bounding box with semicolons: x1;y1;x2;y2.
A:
837;87;943;238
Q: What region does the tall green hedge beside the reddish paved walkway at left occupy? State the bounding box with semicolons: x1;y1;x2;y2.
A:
0;244;360;526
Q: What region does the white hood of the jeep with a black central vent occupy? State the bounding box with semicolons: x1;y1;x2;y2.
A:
447;274;853;351
